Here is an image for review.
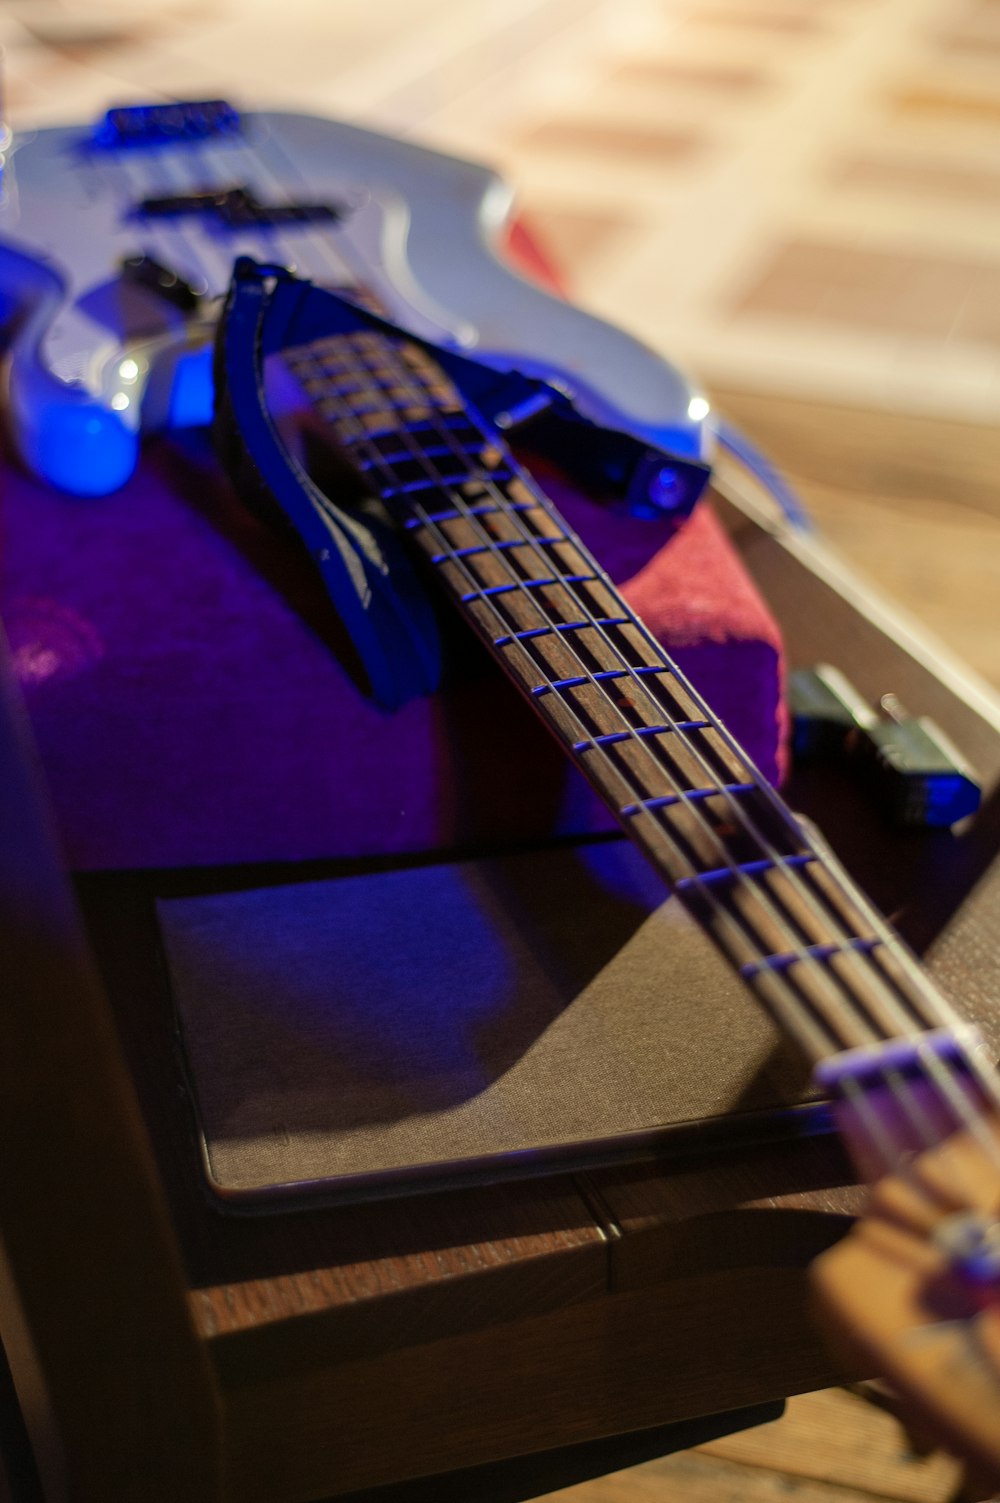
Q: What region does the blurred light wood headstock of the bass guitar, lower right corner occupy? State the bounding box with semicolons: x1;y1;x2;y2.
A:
812;1117;1000;1477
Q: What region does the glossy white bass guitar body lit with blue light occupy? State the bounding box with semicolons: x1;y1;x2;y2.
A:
0;105;708;494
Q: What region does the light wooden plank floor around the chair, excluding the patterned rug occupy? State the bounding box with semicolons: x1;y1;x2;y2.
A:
538;391;1000;1503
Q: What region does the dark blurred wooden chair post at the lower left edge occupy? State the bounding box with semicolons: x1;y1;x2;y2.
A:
0;643;221;1503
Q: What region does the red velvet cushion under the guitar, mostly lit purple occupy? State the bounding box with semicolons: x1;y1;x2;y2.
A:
0;443;782;869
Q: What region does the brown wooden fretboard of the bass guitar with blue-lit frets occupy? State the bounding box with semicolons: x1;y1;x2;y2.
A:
286;331;956;1082
